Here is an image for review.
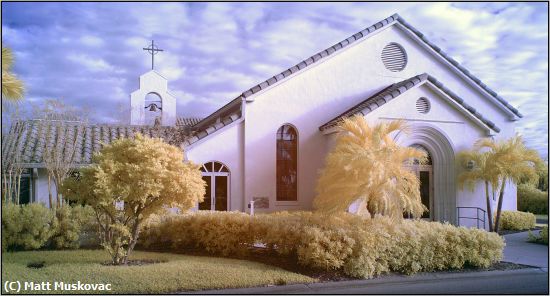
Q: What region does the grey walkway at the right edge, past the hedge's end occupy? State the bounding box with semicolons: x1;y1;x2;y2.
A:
502;231;548;271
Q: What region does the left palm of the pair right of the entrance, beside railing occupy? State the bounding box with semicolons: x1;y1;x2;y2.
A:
457;149;498;231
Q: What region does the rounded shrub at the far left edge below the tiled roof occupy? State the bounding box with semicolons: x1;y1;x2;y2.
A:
2;203;54;250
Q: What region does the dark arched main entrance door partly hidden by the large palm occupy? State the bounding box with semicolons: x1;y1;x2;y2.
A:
408;144;436;221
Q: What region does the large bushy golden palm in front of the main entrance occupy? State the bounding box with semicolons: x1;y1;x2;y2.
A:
313;116;427;219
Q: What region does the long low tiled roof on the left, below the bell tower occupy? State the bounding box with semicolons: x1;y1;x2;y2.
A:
2;120;194;167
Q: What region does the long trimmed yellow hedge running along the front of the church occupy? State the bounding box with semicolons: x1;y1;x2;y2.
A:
140;211;504;278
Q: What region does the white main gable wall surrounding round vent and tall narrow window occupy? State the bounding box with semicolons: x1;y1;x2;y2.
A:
239;20;515;217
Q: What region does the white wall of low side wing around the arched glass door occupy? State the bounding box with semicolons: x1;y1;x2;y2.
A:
184;121;245;211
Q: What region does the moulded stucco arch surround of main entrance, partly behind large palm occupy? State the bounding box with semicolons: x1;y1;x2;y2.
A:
396;124;456;224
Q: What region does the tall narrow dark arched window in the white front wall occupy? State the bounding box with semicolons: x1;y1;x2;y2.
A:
277;124;298;201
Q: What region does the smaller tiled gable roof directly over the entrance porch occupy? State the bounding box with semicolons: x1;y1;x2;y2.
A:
319;73;500;133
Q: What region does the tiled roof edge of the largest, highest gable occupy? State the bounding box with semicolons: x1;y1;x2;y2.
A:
208;14;523;117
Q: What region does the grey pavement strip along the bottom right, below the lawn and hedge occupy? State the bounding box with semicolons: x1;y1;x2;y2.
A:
188;268;548;294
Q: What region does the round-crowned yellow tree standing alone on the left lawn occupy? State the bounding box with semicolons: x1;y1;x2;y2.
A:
62;134;205;265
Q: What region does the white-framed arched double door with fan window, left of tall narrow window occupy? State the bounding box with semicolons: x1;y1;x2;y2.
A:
199;161;229;211
